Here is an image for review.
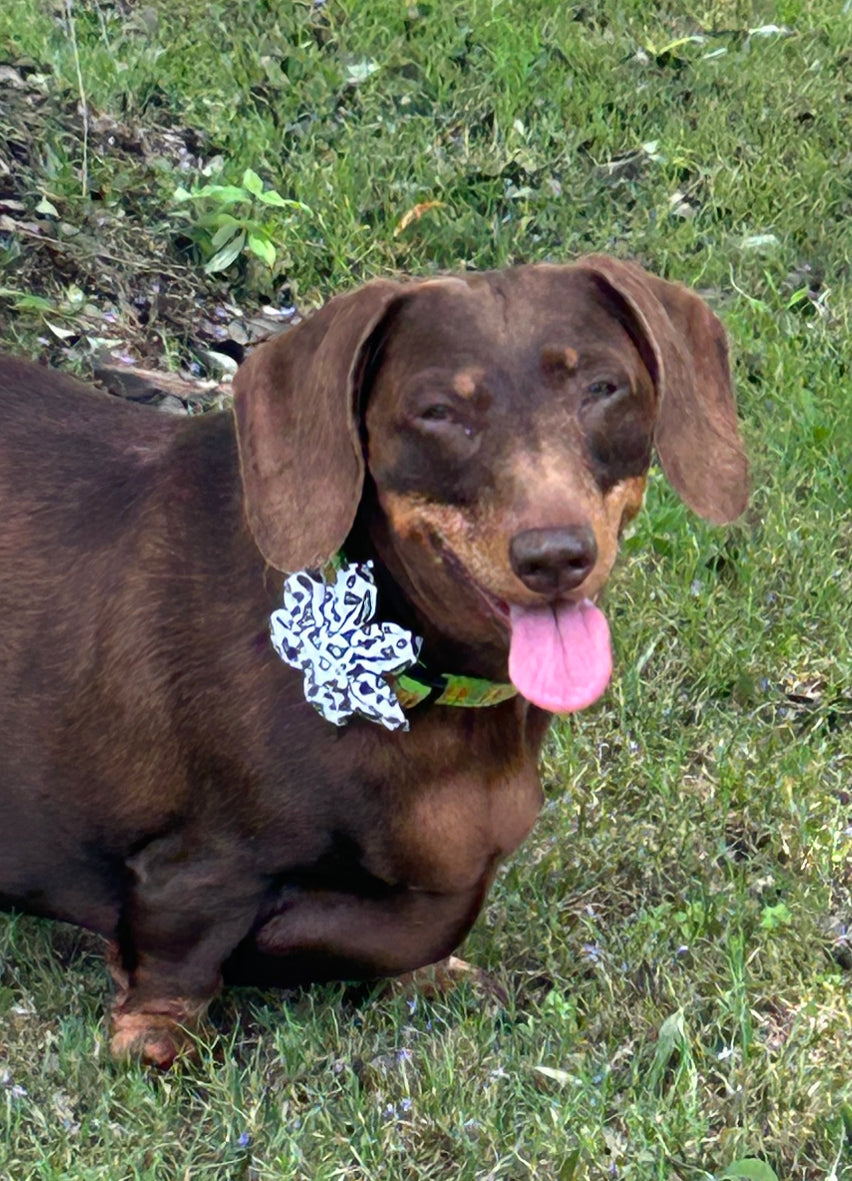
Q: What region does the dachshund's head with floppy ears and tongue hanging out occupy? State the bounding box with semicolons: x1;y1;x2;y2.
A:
235;256;747;711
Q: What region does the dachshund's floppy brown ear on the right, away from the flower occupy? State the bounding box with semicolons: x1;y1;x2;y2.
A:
579;255;748;524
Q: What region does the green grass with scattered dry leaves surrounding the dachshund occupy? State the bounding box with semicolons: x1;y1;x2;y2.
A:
0;0;852;1181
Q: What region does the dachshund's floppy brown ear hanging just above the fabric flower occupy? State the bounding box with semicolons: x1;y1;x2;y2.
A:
234;280;403;572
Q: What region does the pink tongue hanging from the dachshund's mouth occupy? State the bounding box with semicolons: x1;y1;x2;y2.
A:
509;599;612;713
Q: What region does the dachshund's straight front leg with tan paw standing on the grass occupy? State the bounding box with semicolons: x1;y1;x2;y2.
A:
110;842;262;1069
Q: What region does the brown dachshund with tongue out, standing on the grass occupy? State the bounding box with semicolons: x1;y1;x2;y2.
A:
0;256;747;1065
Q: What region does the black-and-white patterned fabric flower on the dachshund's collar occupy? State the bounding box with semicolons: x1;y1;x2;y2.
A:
269;562;422;730
